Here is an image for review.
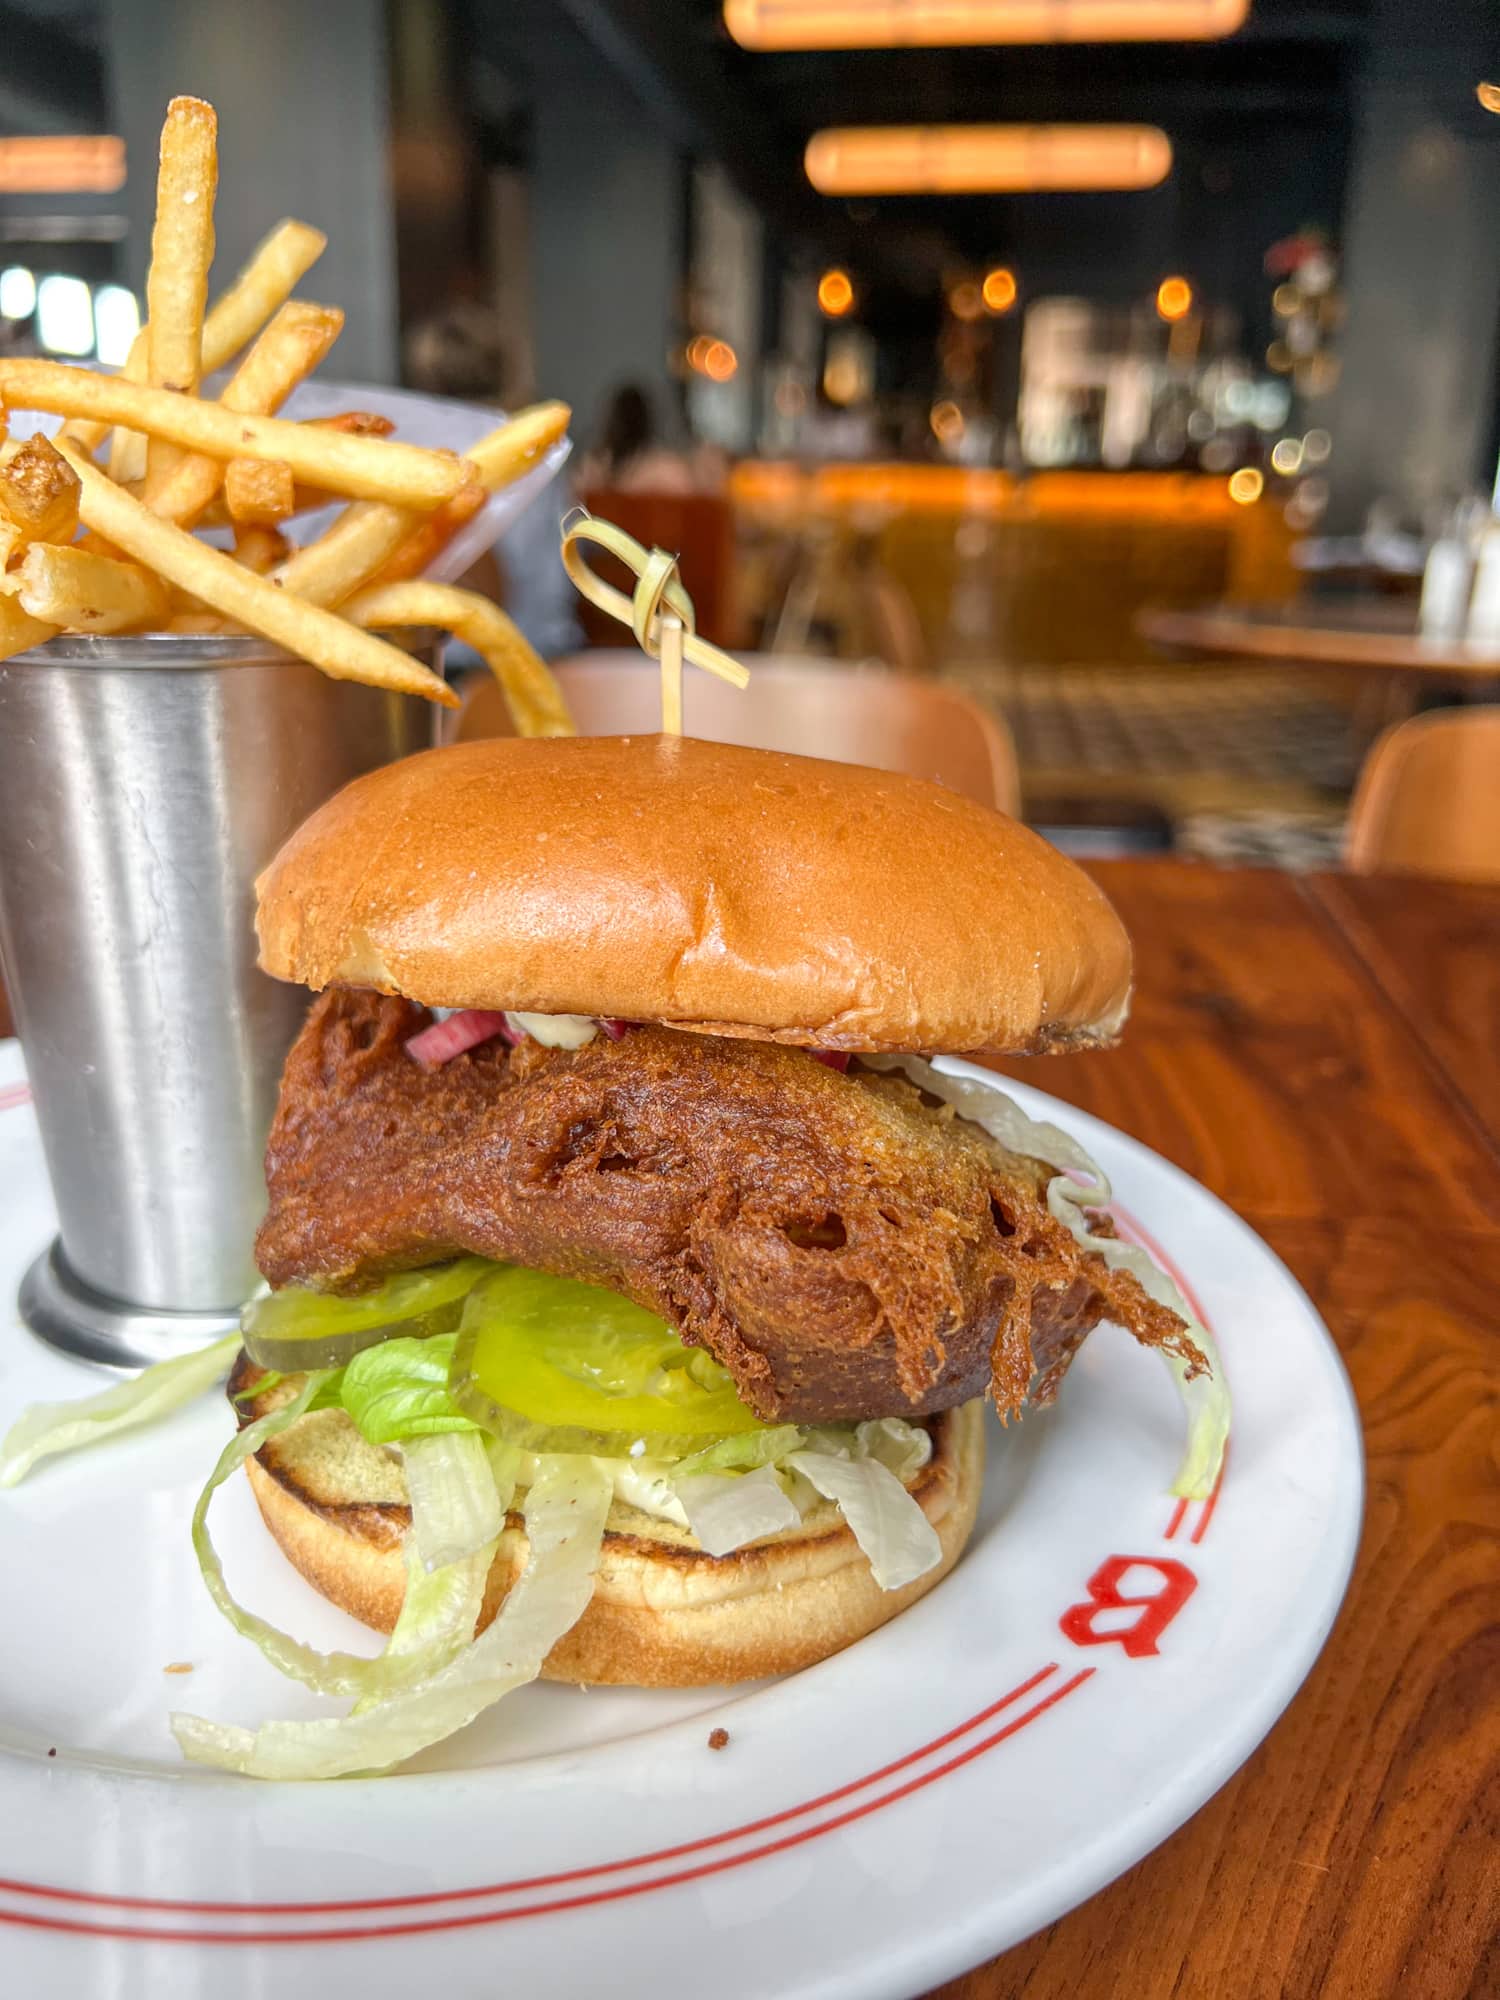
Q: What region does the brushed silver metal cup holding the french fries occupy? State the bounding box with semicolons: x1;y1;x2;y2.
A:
0;634;434;1368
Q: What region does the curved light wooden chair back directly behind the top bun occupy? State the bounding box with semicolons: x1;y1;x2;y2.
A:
454;650;1020;814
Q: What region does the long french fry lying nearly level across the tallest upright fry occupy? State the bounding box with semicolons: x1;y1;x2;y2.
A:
0;360;468;514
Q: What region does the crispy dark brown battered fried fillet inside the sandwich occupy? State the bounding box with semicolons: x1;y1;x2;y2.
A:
256;988;1202;1422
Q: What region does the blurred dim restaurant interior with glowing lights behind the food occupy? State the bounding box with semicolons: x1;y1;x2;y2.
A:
0;0;1500;872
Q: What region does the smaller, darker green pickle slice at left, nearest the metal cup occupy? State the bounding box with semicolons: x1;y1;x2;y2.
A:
240;1256;500;1374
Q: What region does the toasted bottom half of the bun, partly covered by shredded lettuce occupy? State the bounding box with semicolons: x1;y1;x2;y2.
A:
246;1402;984;1688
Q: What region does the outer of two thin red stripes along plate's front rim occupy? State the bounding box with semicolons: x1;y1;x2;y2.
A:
0;1666;1098;1944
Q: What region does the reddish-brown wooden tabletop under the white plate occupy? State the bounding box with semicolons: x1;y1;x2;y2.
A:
942;860;1500;2000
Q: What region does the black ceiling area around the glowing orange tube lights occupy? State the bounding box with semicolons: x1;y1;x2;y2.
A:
554;0;1370;324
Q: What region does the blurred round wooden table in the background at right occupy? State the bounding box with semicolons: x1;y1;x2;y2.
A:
1136;598;1500;688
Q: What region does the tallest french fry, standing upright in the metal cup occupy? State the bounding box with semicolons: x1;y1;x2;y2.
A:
146;98;218;482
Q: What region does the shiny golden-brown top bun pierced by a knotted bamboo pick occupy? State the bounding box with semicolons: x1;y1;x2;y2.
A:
258;736;1130;1054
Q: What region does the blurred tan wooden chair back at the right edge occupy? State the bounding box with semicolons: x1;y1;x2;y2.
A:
1344;706;1500;882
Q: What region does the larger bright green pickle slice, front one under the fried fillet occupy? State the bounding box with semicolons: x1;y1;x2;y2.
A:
448;1264;772;1458
